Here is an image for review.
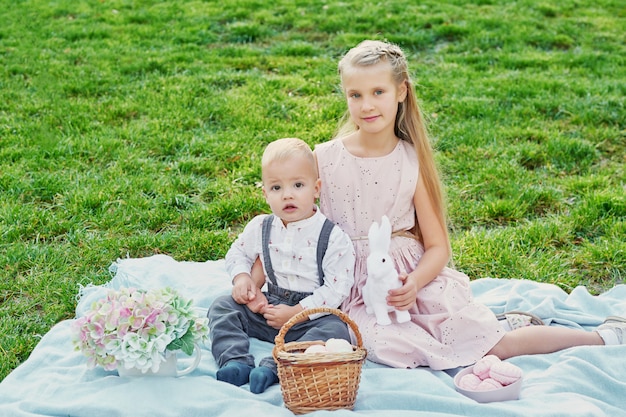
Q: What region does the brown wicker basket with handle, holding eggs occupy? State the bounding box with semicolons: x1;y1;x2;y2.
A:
273;307;367;414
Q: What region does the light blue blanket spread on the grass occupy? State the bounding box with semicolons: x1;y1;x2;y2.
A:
0;255;626;417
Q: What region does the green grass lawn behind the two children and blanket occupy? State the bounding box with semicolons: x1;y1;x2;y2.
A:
0;0;626;378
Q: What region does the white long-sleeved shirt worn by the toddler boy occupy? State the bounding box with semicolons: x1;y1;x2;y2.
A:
225;207;355;310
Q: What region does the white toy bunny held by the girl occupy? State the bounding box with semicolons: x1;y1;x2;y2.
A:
362;216;411;326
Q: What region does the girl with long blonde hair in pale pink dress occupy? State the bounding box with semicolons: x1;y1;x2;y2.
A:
315;41;626;370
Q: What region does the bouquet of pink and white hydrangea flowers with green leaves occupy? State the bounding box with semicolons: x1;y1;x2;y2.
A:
72;288;208;373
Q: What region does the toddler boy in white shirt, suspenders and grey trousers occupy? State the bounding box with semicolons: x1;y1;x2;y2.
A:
208;138;355;394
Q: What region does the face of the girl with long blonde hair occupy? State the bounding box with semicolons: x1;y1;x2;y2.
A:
342;61;407;138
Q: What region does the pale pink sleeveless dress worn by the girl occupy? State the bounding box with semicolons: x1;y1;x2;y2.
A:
315;139;504;370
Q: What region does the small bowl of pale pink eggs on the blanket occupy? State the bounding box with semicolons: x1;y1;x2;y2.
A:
454;355;523;403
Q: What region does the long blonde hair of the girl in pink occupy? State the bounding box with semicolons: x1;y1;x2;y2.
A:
336;40;449;242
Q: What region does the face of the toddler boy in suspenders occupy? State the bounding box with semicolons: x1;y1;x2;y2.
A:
263;156;321;224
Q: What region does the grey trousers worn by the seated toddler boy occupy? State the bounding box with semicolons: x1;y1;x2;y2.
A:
207;293;350;373
